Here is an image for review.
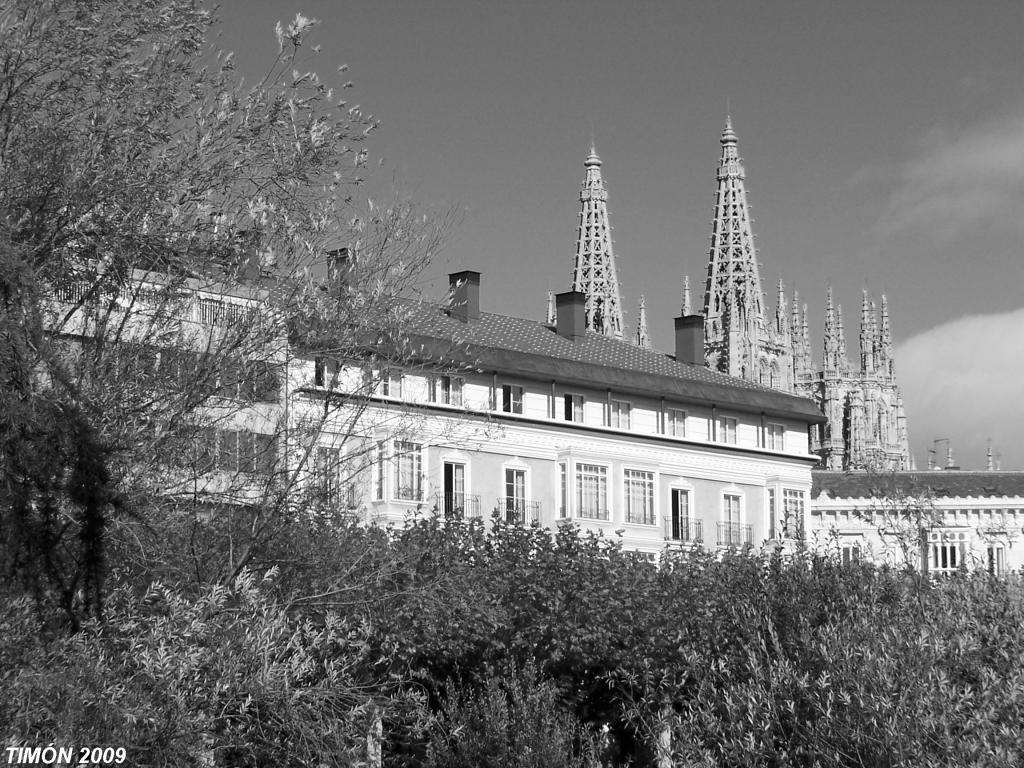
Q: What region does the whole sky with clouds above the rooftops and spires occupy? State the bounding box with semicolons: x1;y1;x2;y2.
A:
217;0;1024;469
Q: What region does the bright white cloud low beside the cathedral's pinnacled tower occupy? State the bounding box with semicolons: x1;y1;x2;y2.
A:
896;308;1024;469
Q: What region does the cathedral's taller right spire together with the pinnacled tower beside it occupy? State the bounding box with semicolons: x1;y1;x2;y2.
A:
683;118;911;471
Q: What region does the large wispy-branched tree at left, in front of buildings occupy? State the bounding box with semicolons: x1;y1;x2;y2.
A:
0;0;446;627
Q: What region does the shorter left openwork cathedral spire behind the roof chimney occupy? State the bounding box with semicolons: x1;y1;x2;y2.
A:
572;143;623;339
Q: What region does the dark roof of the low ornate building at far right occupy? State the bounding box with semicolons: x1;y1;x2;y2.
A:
811;469;1024;499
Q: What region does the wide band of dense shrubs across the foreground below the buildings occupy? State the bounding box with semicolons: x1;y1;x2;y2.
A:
0;520;1024;766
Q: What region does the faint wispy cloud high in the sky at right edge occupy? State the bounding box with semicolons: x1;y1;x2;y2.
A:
874;113;1024;239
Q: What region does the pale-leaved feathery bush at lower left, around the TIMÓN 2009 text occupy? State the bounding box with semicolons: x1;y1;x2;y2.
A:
0;575;422;766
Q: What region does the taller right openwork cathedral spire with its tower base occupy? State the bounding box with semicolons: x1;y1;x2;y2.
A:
703;118;794;391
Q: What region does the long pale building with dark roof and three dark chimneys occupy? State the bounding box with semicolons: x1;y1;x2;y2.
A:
291;272;822;554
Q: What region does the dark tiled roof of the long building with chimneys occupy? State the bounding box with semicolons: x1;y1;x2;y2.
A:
399;303;824;422
